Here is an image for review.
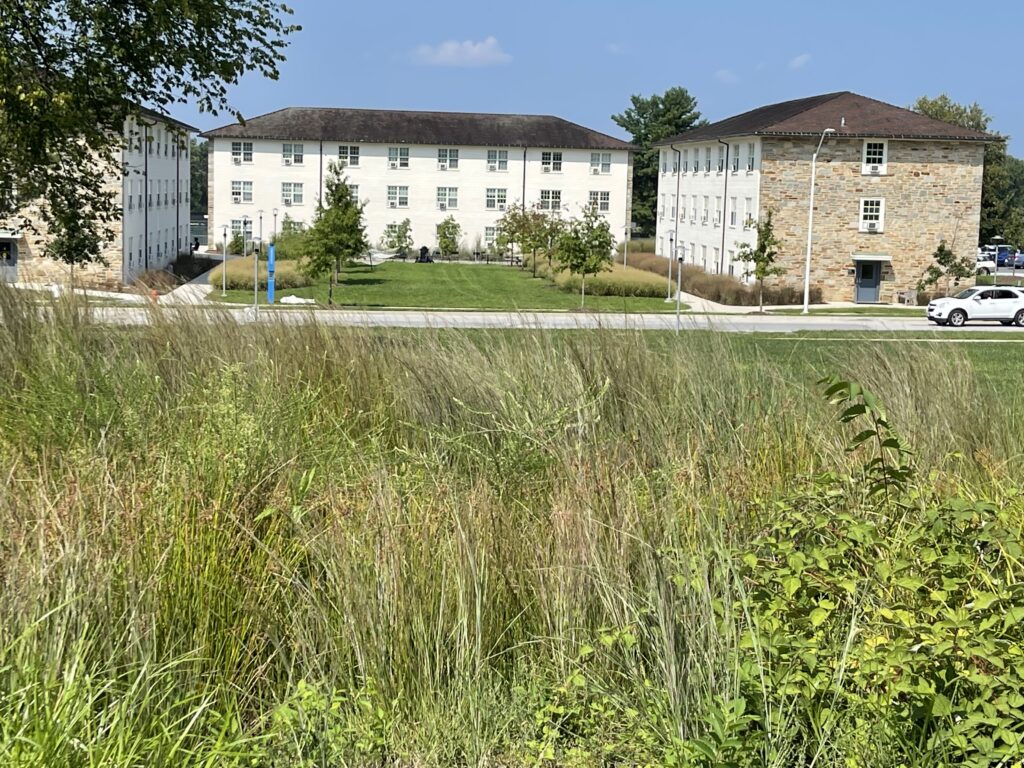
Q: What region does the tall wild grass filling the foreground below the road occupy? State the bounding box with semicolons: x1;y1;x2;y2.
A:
0;292;1022;768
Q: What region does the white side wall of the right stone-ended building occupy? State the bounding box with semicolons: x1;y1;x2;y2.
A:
655;136;761;278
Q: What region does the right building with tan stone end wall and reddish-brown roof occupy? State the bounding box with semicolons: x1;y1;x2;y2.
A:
656;91;998;303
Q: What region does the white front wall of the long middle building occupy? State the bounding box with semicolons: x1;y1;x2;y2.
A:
210;138;630;250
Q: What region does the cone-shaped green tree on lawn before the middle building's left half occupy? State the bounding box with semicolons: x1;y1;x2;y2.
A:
301;162;370;304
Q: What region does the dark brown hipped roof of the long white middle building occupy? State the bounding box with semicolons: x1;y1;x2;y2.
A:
202;106;634;150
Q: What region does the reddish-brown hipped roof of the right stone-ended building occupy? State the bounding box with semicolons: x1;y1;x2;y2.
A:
656;91;999;146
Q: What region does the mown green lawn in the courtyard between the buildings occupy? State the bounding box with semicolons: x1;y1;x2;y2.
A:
210;262;675;312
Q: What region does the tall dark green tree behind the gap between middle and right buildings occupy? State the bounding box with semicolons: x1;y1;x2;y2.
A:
611;87;706;237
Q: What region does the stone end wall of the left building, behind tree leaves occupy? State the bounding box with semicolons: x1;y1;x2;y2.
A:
17;166;124;290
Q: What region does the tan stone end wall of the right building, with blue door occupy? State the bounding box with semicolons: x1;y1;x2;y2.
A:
759;137;984;302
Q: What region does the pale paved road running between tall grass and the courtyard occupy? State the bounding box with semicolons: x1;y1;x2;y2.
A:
83;307;1024;340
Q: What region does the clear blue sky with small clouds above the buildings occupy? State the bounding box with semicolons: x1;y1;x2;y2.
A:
174;0;1024;156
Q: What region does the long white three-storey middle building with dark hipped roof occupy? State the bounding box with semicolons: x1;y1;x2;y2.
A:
203;108;633;250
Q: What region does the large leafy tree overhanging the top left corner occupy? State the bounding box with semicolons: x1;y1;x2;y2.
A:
0;0;299;264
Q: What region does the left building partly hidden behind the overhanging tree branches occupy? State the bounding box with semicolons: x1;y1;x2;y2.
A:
0;110;197;289
